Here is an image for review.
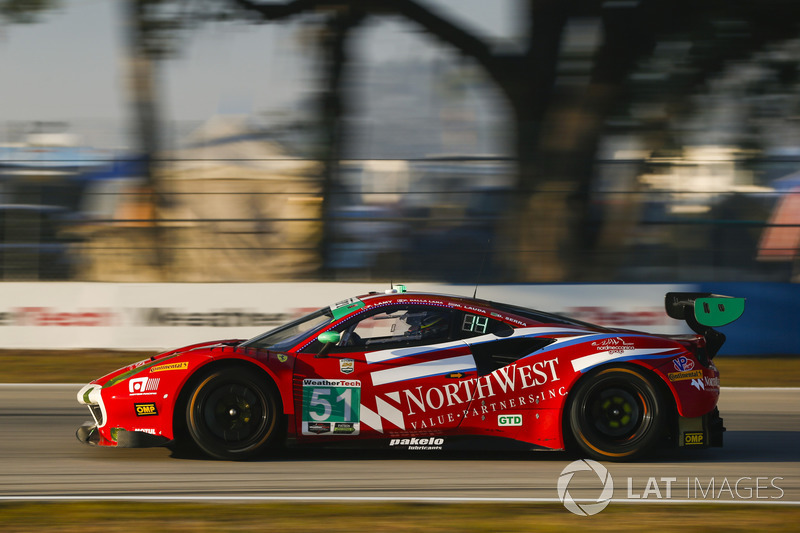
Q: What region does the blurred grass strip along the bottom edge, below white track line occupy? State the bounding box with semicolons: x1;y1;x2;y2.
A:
0;502;800;533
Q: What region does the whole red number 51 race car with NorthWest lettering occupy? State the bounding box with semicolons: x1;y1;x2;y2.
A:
77;286;744;460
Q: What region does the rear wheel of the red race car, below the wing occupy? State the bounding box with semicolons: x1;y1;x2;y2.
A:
568;367;666;461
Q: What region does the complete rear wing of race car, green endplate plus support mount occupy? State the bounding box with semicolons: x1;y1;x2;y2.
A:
664;292;745;363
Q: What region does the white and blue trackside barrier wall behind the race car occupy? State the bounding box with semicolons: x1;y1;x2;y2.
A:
0;282;800;355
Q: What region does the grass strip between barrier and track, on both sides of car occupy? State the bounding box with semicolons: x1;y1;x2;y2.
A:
0;350;800;387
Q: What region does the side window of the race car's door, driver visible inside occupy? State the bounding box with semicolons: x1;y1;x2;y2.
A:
336;306;454;351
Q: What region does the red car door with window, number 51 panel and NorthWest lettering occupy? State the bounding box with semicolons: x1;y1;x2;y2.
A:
295;304;477;440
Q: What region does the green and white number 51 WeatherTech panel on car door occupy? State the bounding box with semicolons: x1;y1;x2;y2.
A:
302;379;361;435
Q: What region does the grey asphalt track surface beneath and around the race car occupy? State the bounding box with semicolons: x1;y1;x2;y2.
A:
0;384;800;505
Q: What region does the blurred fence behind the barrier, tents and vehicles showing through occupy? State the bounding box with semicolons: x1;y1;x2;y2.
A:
0;151;800;283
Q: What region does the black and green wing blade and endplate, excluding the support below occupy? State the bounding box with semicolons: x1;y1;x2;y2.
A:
665;292;745;328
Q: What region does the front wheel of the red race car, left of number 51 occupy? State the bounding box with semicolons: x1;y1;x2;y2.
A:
186;367;280;460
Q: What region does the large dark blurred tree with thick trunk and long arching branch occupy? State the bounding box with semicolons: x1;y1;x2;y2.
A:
222;0;800;281
